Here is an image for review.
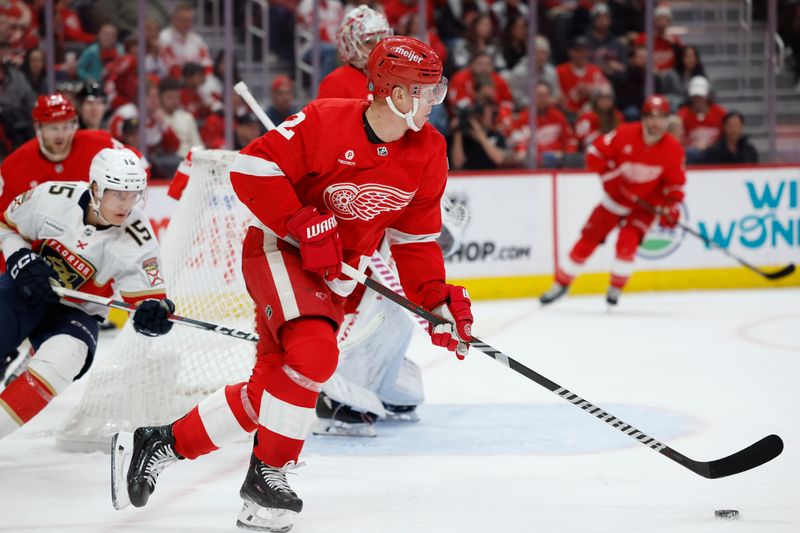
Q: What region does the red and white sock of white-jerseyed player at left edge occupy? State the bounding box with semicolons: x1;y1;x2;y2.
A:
0;370;56;438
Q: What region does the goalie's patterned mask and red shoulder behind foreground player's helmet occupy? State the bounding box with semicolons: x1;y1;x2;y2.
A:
317;6;392;99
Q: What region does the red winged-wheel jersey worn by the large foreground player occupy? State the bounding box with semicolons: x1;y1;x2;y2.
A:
230;98;447;302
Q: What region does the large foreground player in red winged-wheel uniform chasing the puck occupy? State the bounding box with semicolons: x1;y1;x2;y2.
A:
112;37;472;531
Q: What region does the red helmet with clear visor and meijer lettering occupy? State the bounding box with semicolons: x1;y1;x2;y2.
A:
367;36;446;103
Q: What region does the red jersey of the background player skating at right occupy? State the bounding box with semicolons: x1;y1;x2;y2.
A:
586;122;686;211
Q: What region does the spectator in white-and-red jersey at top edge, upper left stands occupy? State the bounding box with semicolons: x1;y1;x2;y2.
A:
158;3;211;79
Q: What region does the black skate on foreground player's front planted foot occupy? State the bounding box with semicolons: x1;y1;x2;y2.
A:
236;454;303;533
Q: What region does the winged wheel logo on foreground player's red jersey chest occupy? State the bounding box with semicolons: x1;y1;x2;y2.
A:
325;183;417;220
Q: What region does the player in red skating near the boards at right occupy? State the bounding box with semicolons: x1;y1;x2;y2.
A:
540;95;686;305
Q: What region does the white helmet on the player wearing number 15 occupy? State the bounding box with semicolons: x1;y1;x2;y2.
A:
89;148;147;218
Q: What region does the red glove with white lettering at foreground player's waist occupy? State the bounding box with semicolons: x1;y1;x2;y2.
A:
286;206;342;281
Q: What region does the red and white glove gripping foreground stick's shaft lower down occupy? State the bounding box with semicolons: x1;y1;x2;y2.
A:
422;285;472;359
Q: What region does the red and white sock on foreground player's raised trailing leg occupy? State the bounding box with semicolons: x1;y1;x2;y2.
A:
172;383;258;459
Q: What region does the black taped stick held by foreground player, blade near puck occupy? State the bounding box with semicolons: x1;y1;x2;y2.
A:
342;263;783;479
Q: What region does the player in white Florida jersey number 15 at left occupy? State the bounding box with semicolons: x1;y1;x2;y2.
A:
0;148;175;438
